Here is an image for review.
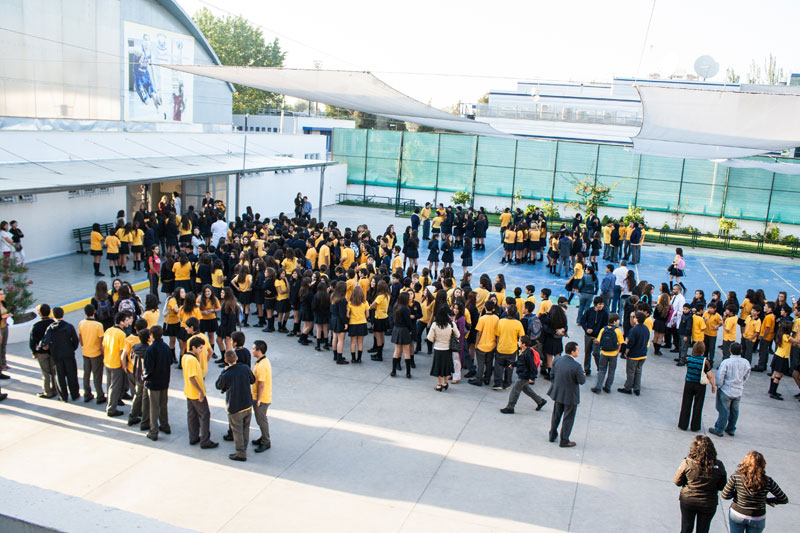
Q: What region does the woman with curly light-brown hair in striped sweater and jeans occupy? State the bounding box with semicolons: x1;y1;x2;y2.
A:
721;451;789;533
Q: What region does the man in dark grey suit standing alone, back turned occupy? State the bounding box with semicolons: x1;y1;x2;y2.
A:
547;342;586;448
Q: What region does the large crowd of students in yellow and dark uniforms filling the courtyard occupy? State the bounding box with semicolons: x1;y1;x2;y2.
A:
3;194;800;520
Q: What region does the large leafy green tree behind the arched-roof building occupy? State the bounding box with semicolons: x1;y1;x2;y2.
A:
193;8;286;114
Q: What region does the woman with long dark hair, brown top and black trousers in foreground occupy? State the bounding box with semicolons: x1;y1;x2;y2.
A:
674;435;727;533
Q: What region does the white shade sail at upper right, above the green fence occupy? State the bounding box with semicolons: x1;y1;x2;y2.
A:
633;86;800;159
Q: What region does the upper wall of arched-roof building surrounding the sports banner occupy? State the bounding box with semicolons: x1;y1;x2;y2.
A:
0;0;231;129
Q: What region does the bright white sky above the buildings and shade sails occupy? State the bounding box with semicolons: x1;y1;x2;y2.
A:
177;0;800;107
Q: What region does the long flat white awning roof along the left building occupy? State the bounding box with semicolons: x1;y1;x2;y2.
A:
0;131;334;195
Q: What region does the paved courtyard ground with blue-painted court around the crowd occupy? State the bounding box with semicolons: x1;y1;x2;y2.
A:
0;206;800;533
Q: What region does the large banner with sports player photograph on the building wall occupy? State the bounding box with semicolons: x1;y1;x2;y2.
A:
123;21;194;123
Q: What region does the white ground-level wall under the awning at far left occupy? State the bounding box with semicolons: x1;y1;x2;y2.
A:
2;187;126;261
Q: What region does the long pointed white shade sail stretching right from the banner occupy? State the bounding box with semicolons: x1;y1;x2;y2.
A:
162;65;511;137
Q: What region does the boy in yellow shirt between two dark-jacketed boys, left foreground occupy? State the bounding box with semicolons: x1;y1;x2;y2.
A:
181;337;219;449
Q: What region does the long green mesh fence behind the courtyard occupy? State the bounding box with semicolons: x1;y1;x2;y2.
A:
333;129;800;228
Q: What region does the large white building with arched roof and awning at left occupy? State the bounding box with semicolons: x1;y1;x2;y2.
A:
0;0;346;260
